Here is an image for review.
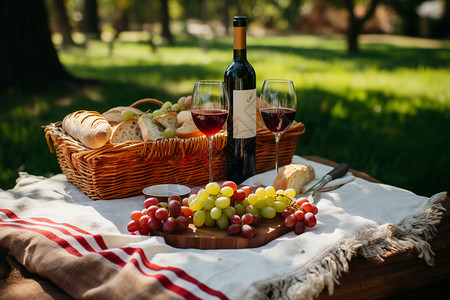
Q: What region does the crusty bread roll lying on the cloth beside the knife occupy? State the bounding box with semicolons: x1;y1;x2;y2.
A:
273;164;316;194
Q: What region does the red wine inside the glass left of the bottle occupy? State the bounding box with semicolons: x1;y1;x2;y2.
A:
191;109;228;136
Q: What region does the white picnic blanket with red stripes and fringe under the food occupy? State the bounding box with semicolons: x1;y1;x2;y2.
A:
0;156;446;299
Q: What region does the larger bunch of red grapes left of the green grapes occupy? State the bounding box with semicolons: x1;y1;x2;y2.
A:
127;195;192;235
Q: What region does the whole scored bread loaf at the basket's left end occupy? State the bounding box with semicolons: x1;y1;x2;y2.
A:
62;110;112;149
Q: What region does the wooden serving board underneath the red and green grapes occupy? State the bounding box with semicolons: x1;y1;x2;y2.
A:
152;216;292;249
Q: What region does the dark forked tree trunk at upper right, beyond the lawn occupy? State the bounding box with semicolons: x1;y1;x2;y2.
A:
344;0;379;53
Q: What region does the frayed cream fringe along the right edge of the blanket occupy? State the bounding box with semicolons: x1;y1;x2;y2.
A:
247;192;447;300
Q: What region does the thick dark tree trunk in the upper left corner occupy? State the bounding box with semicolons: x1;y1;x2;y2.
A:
0;0;74;91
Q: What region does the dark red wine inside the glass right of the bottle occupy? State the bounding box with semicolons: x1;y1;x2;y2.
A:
261;107;295;133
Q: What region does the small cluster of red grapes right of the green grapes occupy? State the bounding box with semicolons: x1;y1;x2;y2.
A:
282;197;318;234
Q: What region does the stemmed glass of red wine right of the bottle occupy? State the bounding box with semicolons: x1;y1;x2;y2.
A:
259;79;297;174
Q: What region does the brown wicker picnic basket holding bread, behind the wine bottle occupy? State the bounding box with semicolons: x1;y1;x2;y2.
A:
45;98;304;200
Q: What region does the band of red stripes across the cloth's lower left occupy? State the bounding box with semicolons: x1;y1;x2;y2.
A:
0;209;228;299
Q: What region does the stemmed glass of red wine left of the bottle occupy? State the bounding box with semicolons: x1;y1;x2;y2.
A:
191;80;230;182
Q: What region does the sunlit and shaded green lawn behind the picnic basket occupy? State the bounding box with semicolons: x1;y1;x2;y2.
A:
0;36;450;196
